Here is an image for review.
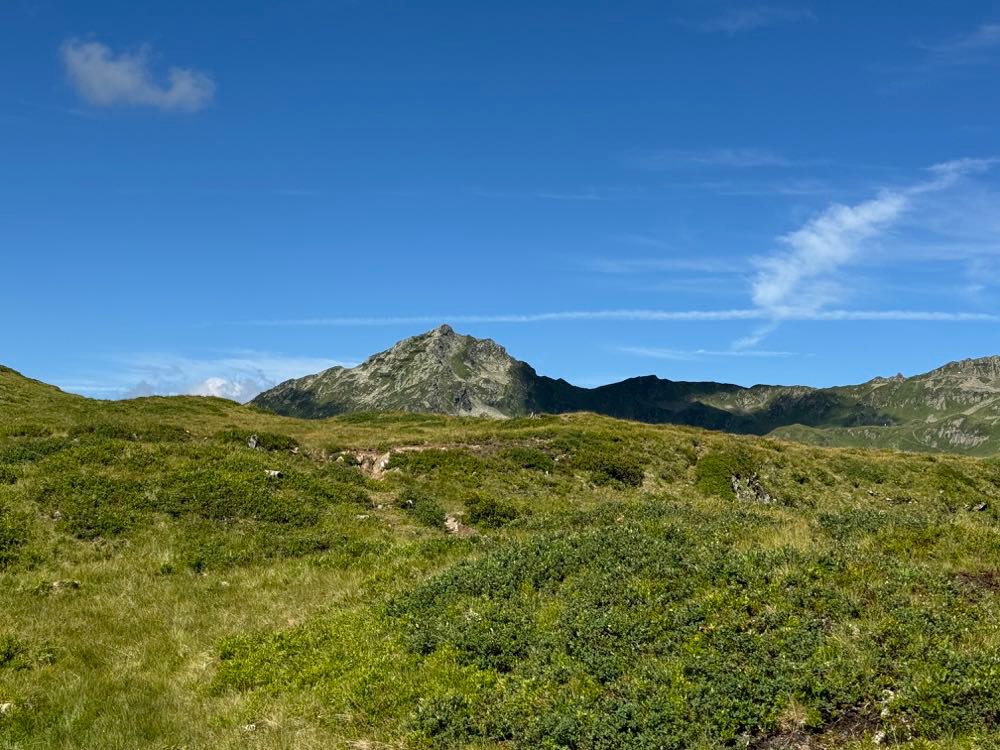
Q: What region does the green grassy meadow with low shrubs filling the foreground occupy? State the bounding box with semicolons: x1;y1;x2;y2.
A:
0;371;1000;750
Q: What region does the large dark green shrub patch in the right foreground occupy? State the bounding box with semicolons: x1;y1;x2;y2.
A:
389;506;1000;750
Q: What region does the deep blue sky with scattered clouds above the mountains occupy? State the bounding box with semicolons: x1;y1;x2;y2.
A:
0;0;1000;399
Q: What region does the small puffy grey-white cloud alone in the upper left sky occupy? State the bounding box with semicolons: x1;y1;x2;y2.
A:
60;39;216;112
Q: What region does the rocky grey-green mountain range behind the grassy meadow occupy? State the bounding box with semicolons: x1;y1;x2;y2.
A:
251;325;1000;455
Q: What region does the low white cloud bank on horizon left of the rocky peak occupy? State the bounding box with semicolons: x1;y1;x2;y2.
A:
57;351;354;402
